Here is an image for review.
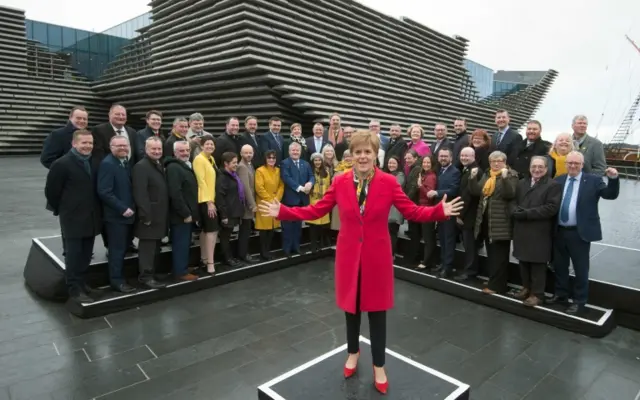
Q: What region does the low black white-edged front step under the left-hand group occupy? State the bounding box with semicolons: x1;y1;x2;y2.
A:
67;245;333;318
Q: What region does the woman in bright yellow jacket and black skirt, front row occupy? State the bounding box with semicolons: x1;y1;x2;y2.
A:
193;136;220;274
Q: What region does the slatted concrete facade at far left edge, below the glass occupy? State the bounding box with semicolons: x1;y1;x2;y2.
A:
0;7;108;154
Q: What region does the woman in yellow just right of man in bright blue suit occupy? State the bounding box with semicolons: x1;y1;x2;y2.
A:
307;153;331;252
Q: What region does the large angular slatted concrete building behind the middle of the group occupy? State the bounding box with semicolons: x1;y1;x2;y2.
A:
1;0;557;155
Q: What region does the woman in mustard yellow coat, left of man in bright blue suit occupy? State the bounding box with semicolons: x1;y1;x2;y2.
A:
255;150;284;261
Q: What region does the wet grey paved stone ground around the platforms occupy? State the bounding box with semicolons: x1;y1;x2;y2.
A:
0;158;640;400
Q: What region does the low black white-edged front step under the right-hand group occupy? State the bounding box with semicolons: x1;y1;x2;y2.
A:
394;265;615;338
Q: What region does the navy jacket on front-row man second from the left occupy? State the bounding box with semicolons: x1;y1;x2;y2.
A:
98;154;136;224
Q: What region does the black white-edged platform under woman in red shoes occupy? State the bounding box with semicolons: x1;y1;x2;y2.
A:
258;336;470;400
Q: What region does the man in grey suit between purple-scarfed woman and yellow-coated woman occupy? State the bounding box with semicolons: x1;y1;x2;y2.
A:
236;144;257;263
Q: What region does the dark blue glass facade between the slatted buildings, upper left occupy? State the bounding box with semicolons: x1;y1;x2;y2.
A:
25;20;129;80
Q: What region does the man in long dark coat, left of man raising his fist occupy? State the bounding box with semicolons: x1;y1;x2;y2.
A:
513;156;562;307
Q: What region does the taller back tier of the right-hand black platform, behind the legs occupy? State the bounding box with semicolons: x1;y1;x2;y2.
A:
398;231;640;330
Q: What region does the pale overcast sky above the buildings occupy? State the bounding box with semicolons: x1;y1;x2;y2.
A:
5;0;640;143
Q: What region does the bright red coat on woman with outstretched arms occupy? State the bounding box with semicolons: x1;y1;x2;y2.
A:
278;169;446;313
